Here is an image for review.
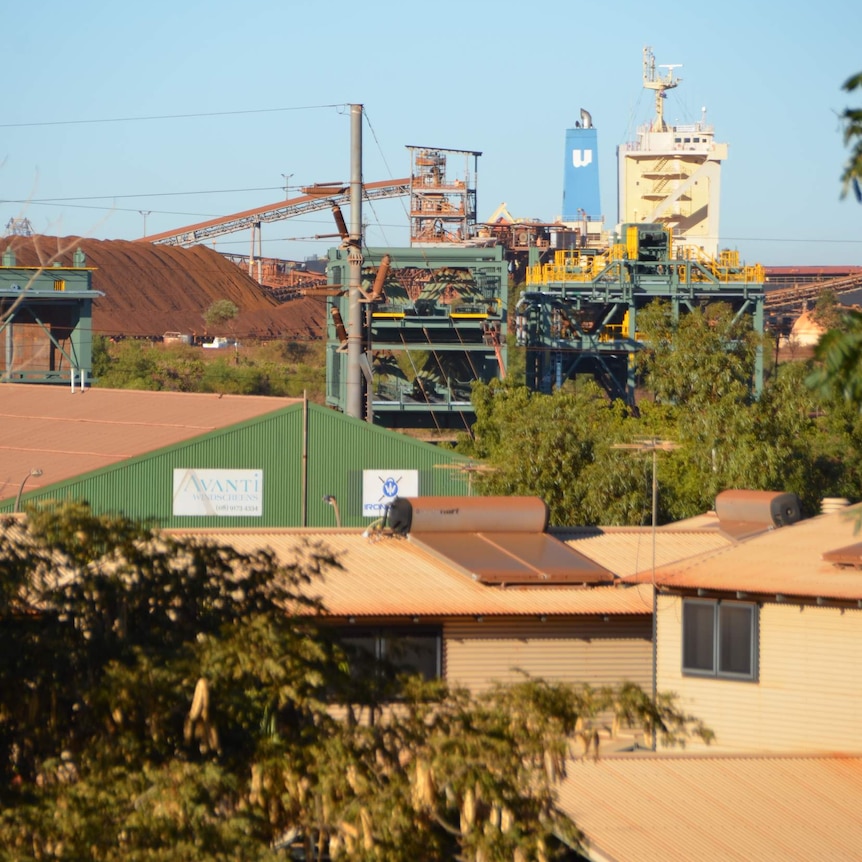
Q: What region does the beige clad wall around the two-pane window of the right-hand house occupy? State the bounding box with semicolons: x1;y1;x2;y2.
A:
658;596;862;752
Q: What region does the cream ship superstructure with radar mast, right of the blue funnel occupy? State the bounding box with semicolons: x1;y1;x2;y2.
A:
617;47;727;257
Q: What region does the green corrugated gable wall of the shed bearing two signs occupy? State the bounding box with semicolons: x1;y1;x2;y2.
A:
0;402;471;528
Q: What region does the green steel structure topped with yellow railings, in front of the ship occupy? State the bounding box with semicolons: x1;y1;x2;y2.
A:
515;223;765;404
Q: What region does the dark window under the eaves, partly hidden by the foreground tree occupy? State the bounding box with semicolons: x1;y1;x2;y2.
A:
338;626;442;679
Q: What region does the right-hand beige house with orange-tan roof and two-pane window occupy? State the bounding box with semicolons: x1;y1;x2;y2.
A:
636;496;862;752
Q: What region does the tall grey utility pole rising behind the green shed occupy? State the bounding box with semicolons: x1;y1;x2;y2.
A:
346;105;365;419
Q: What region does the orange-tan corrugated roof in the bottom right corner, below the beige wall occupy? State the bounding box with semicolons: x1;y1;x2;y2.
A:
559;754;862;862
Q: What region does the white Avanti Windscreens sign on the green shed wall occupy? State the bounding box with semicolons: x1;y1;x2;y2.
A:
173;469;263;518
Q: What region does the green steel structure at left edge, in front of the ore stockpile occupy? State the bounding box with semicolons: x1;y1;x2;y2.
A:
0;249;101;386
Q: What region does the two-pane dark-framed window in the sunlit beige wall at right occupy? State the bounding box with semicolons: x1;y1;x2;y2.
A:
682;599;758;680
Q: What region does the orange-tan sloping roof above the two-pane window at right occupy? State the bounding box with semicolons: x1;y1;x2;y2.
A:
636;505;862;601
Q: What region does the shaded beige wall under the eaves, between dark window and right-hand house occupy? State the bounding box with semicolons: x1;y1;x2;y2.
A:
443;615;652;692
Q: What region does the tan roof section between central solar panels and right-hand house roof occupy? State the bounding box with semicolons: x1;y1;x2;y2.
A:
553;525;735;580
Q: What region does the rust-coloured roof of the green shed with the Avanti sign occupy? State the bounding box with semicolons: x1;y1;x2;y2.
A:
0;383;296;499
